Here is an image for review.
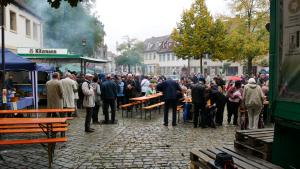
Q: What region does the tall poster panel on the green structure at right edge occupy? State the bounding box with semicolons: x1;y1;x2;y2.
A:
278;0;300;101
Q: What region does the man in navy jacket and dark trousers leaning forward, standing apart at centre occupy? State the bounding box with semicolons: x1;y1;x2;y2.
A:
157;79;181;126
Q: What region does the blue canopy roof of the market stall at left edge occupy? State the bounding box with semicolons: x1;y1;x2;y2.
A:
0;49;36;71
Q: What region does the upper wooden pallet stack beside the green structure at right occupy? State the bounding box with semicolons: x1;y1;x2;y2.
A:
234;128;274;161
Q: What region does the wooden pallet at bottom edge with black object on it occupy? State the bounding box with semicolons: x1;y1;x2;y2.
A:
190;146;281;169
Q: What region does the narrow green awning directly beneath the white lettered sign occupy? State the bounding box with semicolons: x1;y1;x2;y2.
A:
18;54;81;59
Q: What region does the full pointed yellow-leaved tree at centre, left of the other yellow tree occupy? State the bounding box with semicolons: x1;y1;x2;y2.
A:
172;0;226;73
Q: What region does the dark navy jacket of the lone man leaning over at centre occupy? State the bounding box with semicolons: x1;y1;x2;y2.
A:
156;80;181;100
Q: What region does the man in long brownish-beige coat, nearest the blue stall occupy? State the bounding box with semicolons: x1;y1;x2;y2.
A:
46;72;63;117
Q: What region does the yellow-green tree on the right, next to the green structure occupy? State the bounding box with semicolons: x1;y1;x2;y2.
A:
227;0;270;75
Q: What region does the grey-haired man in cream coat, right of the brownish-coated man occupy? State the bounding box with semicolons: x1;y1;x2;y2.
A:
61;72;76;117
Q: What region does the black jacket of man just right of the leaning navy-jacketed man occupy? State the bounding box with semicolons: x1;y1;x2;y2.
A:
191;83;206;106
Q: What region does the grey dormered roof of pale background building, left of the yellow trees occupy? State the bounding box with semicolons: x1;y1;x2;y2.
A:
144;35;174;53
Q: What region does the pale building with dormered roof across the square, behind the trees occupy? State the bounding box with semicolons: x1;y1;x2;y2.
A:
144;36;262;76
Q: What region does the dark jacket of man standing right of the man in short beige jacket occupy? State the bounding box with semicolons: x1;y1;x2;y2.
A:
100;80;117;99
